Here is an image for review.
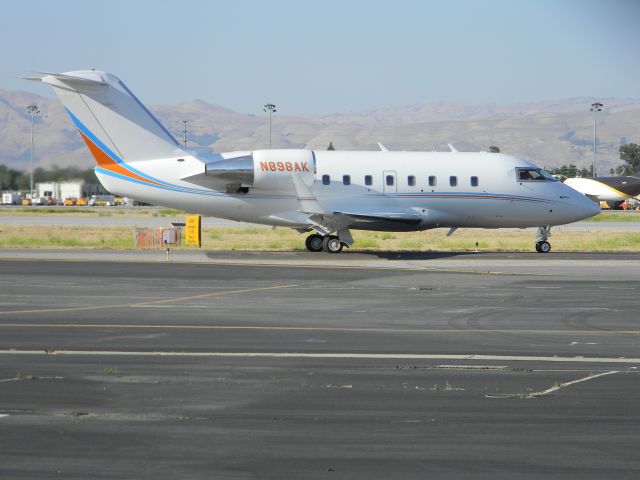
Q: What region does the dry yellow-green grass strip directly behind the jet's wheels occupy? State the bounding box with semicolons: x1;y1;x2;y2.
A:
0;224;640;252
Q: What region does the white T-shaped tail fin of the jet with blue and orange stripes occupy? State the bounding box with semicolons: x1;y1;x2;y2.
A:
41;70;184;166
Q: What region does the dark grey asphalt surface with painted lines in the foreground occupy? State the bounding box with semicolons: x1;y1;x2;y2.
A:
0;250;640;479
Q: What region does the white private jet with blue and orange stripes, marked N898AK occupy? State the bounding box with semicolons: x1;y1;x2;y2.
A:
30;70;600;253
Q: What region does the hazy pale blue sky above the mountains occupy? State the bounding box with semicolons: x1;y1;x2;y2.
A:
0;0;640;113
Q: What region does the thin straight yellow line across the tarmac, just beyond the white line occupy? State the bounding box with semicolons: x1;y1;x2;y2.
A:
0;322;640;336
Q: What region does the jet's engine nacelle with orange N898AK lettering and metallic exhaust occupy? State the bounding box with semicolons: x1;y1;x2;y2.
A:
206;149;316;192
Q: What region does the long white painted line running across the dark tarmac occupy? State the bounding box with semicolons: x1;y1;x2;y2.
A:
0;349;640;364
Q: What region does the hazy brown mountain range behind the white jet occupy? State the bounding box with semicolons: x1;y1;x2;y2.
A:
0;90;640;173
